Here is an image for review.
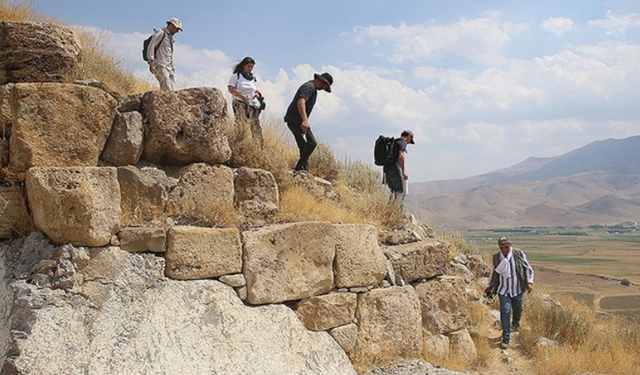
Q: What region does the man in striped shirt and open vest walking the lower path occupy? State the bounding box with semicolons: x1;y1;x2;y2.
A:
485;236;533;349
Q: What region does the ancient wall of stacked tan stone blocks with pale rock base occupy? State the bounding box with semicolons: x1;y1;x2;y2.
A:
0;22;482;374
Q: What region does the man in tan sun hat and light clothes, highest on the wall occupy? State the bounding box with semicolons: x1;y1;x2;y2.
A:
147;17;182;91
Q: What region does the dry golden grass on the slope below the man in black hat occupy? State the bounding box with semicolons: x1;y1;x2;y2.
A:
227;120;403;228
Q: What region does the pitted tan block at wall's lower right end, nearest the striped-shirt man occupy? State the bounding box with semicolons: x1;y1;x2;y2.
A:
415;276;469;334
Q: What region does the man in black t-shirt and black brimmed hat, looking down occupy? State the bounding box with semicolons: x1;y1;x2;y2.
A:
284;73;333;174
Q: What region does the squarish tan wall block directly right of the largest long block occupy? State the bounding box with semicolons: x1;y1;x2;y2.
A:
334;224;387;288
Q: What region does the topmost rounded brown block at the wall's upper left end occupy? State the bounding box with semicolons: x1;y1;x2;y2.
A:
0;22;82;85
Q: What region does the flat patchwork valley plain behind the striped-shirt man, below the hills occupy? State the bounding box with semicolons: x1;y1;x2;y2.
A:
463;232;640;321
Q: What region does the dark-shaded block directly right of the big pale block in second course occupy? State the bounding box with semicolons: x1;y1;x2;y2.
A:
118;165;174;226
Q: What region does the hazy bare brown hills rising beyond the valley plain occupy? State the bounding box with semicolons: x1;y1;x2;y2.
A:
407;136;640;229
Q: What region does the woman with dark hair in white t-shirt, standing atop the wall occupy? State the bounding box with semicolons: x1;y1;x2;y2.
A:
227;56;265;146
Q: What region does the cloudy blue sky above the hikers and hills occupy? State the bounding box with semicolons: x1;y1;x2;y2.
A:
26;0;640;182
